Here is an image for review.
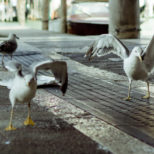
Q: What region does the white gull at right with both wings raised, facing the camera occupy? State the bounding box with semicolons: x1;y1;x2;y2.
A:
84;34;154;100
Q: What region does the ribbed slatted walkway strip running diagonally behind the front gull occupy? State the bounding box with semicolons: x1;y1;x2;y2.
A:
1;53;154;146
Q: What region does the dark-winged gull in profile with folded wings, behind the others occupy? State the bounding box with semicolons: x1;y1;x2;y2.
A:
0;33;19;66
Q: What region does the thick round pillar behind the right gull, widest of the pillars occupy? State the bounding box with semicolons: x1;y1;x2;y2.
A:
109;0;140;38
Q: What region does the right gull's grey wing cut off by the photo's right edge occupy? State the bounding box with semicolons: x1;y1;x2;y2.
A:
142;35;154;72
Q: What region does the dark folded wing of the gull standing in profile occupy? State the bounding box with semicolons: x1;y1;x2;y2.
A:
0;40;17;54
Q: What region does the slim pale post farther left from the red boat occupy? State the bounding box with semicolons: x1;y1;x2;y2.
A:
42;0;49;30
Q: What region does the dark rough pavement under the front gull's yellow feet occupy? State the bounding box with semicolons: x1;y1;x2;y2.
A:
0;87;110;154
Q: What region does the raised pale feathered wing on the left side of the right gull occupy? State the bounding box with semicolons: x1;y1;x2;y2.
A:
85;34;130;59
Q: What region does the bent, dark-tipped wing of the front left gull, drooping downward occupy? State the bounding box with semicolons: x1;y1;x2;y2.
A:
31;60;68;95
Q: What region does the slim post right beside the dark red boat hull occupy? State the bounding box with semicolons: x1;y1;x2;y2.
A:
60;0;67;33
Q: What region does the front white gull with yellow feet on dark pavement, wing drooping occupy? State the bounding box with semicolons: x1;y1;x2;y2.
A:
5;60;68;131
